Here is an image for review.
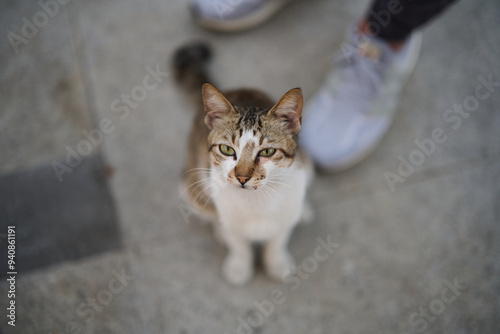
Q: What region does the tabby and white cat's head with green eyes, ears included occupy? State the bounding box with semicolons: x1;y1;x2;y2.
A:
203;84;303;190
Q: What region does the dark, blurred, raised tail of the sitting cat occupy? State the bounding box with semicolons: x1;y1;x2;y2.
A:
172;42;212;104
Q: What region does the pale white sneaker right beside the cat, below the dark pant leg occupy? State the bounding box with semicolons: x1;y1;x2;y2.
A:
299;27;422;171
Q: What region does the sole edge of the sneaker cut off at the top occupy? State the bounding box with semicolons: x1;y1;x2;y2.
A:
189;0;295;32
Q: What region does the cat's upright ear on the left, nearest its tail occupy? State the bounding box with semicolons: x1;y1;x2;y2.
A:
201;83;235;129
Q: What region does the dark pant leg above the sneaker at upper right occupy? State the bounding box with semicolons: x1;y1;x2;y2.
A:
367;0;456;41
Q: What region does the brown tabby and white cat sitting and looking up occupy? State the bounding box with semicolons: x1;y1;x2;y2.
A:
173;43;313;286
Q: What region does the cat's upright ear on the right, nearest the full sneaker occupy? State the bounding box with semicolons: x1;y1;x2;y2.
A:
269;88;304;135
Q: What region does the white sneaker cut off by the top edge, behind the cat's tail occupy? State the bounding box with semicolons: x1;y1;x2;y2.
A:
189;0;293;32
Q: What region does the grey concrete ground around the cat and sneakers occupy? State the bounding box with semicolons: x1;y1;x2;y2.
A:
0;0;500;334
